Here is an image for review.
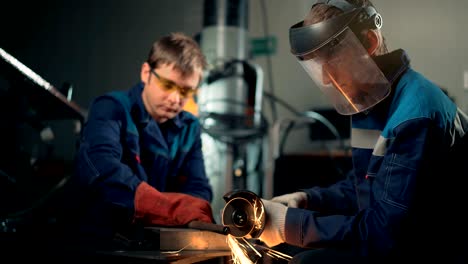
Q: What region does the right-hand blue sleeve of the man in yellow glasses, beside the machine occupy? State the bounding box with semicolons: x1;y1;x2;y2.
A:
176;121;213;202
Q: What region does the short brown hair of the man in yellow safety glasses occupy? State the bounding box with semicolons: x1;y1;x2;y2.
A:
147;32;208;77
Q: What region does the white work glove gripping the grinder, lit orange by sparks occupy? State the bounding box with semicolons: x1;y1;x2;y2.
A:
259;199;288;247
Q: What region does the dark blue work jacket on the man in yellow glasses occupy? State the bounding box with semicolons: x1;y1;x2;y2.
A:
70;83;212;237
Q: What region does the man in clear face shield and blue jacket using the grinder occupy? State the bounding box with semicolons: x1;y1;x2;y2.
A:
260;0;468;263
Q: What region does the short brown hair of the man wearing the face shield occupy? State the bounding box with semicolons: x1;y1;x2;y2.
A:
303;0;388;55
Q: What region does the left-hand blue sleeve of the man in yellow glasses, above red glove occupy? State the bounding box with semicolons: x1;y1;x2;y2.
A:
75;97;142;221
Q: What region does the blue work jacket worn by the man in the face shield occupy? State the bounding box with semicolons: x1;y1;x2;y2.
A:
285;50;468;256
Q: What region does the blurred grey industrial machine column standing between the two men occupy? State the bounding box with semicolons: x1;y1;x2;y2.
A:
197;0;267;222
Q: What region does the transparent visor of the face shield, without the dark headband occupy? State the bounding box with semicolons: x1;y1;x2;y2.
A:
299;28;391;115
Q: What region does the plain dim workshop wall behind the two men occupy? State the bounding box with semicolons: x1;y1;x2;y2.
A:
0;0;468;234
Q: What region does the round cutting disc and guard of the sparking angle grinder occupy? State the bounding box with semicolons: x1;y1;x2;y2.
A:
221;190;265;238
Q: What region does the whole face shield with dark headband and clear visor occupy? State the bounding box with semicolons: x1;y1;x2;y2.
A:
289;5;391;115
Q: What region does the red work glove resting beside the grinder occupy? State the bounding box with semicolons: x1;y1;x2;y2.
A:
135;182;214;226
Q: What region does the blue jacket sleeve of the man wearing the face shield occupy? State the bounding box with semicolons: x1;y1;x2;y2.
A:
285;119;447;255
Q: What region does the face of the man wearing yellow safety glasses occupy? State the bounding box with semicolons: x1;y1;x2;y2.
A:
141;63;200;123
